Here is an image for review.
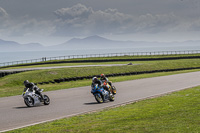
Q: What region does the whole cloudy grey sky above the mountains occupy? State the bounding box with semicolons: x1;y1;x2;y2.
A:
0;0;200;46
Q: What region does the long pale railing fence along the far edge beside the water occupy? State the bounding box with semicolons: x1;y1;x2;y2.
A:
0;50;200;67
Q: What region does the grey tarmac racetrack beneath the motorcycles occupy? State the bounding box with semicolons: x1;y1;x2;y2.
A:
0;71;200;132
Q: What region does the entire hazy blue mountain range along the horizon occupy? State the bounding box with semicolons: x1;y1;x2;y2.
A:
0;36;200;52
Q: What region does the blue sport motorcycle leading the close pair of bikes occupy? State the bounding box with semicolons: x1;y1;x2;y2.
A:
91;84;115;103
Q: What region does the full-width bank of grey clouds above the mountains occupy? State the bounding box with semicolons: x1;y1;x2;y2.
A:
0;3;200;40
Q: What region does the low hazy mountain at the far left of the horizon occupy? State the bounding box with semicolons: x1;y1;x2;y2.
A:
0;39;44;52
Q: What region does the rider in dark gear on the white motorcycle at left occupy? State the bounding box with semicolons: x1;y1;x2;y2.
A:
24;80;44;101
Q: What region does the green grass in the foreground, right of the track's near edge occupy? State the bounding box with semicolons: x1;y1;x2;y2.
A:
7;87;200;133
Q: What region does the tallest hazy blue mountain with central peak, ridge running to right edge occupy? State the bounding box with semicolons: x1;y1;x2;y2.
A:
51;35;200;49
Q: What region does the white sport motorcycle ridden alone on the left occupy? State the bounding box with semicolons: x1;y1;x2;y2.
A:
22;88;50;107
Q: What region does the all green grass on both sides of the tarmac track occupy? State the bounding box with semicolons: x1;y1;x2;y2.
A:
0;54;200;133
